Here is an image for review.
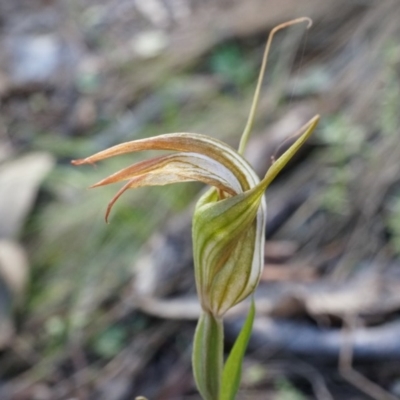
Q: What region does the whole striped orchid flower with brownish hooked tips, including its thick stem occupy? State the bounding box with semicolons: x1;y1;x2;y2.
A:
73;18;319;399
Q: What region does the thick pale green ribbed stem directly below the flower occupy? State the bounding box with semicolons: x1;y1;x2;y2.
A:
192;312;224;400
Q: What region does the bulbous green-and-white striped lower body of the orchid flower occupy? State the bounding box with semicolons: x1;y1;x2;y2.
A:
192;186;266;316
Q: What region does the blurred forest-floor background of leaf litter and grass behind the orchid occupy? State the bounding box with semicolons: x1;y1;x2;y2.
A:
0;0;400;400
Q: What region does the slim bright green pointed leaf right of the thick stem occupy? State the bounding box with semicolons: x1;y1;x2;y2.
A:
219;298;256;400
